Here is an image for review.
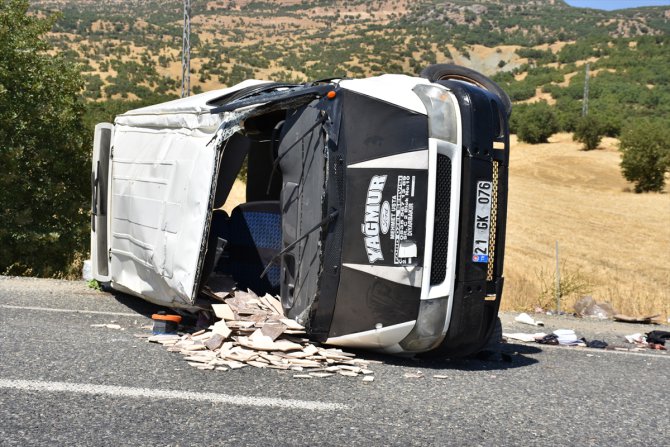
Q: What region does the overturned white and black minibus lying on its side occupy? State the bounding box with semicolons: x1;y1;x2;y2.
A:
91;65;510;356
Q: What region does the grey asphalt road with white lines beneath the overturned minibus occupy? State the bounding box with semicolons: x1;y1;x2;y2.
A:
0;277;670;446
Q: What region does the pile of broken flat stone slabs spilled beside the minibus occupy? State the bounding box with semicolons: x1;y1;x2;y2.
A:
142;291;374;382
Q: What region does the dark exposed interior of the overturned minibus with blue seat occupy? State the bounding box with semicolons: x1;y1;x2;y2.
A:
200;110;286;295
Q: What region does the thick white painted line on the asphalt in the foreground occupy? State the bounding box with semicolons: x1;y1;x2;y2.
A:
0;379;349;411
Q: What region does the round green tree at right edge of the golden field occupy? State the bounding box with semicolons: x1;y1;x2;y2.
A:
619;119;670;193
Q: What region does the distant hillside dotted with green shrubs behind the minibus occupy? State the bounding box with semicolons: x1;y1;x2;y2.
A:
32;0;670;109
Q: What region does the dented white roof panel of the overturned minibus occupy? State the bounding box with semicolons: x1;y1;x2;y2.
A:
110;123;217;307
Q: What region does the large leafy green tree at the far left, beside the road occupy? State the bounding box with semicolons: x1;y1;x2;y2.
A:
0;0;89;276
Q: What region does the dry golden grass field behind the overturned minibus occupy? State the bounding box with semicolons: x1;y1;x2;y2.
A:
224;133;670;319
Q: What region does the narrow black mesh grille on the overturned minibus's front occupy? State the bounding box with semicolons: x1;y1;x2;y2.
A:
430;154;451;286
